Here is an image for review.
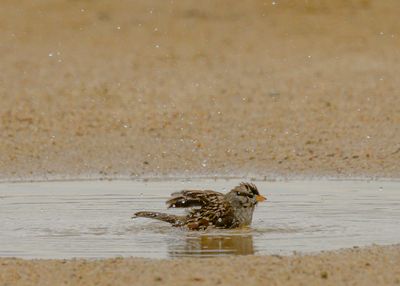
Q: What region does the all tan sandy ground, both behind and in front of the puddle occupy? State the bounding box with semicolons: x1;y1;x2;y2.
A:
0;0;400;285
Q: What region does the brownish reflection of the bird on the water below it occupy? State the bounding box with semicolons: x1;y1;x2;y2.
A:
169;233;254;257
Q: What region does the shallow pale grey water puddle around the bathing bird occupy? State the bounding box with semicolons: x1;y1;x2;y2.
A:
0;179;400;258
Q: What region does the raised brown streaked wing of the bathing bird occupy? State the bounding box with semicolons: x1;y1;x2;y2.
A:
166;190;224;208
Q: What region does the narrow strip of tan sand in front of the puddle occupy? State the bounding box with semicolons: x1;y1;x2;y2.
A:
0;244;400;285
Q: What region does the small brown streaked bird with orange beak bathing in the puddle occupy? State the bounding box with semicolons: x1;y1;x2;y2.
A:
132;183;266;230
